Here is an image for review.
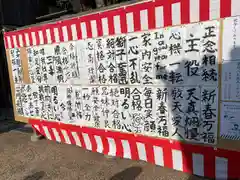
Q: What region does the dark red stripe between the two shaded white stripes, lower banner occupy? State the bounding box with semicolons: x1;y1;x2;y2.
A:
204;151;216;178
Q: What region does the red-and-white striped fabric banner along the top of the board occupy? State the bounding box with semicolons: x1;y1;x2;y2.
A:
4;0;240;49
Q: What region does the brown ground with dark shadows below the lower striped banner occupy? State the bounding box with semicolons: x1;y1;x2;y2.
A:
0;122;207;180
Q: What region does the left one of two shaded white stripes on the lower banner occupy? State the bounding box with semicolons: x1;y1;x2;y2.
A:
192;153;204;176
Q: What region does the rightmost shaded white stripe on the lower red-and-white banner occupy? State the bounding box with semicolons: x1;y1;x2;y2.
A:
215;157;228;180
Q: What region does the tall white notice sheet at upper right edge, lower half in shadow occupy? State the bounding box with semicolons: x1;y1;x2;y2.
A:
222;16;240;101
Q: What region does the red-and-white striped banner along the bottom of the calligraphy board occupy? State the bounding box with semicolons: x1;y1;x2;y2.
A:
29;119;240;179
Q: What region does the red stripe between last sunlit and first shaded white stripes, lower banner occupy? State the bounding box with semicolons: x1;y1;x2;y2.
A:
181;150;193;174
